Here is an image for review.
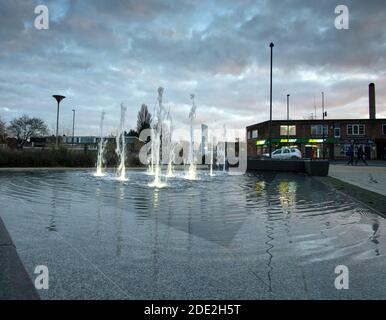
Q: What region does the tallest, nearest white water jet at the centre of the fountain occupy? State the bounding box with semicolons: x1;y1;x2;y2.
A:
149;87;166;188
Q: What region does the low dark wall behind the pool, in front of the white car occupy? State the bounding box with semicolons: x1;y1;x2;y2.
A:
247;158;329;176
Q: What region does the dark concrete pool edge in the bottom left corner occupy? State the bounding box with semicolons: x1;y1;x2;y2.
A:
0;217;40;300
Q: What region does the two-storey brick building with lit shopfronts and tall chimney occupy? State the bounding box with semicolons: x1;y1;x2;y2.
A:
246;84;386;160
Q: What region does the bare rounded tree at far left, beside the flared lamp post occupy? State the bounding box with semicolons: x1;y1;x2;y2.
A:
8;115;48;147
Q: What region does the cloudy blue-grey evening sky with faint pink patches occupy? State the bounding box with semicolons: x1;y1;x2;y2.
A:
0;0;386;135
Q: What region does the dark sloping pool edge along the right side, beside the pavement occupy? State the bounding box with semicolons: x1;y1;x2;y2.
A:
313;176;386;218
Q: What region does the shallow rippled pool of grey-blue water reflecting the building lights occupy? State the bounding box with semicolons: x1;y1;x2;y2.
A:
0;170;386;299
